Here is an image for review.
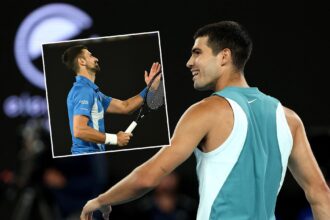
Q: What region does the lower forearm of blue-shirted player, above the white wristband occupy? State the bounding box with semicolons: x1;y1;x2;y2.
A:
74;126;105;143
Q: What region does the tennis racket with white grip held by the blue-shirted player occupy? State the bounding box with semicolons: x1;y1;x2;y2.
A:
125;71;164;133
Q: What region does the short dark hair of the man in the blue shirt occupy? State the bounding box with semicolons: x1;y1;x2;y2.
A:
62;45;88;73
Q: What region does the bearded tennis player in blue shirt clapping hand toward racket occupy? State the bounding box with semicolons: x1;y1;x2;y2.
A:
62;45;160;154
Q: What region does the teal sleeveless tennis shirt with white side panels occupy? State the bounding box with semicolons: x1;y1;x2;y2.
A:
195;87;293;220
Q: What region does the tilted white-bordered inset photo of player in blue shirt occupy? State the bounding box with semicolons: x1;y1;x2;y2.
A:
42;31;170;158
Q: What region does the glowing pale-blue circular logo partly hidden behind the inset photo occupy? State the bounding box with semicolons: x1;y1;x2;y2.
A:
14;3;93;89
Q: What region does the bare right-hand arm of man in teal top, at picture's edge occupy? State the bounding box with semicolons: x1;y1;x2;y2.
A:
285;109;330;220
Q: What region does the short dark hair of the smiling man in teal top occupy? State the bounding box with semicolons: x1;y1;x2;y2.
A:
194;21;252;70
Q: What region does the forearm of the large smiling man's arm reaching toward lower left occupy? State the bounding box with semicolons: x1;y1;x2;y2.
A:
97;168;154;206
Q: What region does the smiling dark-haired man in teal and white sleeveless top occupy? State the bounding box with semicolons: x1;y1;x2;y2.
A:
81;21;330;220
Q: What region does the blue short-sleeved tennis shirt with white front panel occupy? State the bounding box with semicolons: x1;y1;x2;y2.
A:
67;75;112;154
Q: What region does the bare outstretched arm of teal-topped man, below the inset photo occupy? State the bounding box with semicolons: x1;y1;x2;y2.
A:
81;99;220;219
